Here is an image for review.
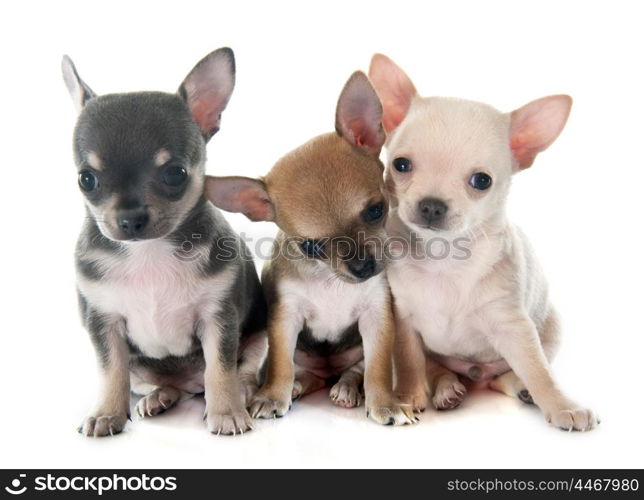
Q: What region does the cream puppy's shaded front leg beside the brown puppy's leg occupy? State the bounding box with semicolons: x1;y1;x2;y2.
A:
394;310;429;412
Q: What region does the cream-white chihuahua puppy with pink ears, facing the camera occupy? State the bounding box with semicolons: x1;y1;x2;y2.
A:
369;54;598;430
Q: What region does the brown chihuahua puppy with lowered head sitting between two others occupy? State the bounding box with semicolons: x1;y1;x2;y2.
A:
206;72;415;424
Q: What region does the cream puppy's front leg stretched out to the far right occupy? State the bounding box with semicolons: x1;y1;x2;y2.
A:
490;310;598;431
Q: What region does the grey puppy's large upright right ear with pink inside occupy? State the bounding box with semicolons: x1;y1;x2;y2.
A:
179;47;235;141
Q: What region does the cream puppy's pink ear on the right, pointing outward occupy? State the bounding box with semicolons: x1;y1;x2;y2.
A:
510;95;572;170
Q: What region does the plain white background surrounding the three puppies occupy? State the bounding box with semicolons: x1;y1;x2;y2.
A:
0;0;644;468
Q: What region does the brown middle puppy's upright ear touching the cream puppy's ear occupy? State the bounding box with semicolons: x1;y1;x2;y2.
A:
335;71;385;156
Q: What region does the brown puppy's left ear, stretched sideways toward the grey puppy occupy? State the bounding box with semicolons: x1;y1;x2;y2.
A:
204;175;275;221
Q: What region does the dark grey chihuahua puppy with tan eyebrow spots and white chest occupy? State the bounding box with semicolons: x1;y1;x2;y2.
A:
63;48;266;436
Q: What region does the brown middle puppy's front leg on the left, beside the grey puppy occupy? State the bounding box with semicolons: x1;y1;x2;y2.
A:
249;303;304;418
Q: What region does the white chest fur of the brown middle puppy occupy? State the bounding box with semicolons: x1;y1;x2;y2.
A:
279;274;389;342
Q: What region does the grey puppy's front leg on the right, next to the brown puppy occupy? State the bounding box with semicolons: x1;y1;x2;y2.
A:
200;314;252;435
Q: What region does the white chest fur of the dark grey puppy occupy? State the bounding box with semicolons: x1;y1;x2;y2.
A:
79;240;235;358
